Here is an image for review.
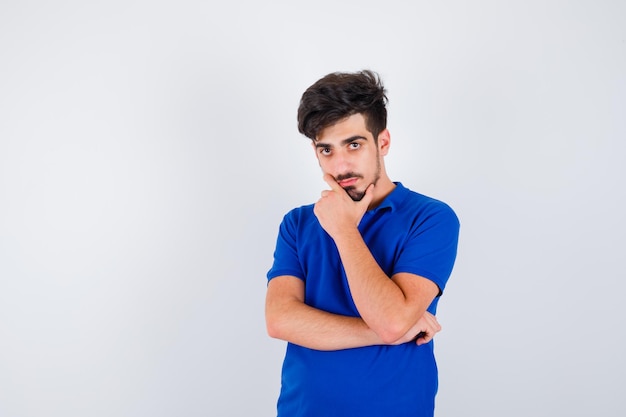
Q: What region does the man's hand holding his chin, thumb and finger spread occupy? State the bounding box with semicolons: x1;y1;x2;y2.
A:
313;174;374;238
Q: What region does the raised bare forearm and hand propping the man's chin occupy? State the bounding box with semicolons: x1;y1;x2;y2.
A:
314;174;439;343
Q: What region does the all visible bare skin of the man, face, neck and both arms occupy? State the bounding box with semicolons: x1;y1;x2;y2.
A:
265;114;441;350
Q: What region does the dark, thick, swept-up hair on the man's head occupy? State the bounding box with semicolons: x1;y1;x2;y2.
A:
298;70;387;141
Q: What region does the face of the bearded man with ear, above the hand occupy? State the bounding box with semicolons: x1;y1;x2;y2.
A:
313;114;389;201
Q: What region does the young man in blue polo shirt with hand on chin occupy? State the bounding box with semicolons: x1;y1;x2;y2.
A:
266;71;459;417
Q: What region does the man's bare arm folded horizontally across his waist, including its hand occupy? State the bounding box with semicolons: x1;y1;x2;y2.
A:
265;276;441;350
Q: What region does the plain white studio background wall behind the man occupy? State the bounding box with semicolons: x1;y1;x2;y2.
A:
0;0;626;417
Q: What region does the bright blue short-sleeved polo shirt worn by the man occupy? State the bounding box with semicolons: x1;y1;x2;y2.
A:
267;183;459;417
